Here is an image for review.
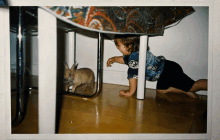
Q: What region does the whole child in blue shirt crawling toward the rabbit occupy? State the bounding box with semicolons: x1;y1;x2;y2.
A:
107;35;207;98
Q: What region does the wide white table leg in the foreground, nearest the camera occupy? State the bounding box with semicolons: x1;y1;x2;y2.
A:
38;8;57;134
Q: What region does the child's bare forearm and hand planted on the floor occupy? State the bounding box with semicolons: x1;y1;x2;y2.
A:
119;78;137;97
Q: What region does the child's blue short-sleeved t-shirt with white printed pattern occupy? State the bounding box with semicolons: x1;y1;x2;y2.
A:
123;51;166;81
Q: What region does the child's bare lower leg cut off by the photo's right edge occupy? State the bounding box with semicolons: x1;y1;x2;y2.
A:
189;79;208;92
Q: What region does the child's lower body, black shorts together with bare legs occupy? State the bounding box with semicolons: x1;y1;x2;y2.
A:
157;61;207;98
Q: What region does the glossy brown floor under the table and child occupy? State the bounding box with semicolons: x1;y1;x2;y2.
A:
12;84;207;134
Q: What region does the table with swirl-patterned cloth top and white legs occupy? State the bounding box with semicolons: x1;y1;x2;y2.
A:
12;6;194;134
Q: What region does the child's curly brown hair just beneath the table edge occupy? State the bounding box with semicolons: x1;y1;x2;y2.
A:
114;34;150;52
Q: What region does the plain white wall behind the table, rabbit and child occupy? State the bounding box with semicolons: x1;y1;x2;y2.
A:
11;7;208;94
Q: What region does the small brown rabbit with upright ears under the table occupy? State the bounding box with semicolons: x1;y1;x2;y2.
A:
64;63;95;92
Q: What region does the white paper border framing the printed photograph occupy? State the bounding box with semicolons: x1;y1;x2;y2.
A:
0;0;217;139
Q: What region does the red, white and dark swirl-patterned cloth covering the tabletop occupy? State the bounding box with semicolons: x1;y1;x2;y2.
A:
41;6;195;35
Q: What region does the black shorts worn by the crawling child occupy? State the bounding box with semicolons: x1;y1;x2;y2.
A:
157;60;195;91
